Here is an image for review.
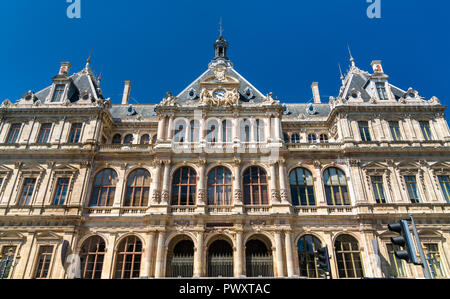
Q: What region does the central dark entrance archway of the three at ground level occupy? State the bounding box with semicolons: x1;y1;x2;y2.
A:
207;240;234;277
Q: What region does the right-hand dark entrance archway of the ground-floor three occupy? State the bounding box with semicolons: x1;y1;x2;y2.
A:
245;239;274;277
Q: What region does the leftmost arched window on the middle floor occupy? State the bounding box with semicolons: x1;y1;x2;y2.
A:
89;169;117;207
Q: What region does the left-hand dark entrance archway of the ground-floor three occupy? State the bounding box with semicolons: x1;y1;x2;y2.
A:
167;238;194;277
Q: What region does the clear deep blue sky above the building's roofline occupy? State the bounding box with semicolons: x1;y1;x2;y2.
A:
0;0;450;110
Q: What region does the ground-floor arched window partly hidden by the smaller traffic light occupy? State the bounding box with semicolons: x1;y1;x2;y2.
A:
298;235;322;278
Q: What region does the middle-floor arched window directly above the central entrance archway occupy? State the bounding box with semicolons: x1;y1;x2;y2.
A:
208;166;233;206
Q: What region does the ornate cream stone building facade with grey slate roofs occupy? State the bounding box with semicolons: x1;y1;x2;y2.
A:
0;36;450;279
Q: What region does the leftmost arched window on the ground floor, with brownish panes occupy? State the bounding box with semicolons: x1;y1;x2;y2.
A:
80;236;106;279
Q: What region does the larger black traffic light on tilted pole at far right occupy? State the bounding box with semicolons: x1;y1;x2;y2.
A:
388;220;419;265
